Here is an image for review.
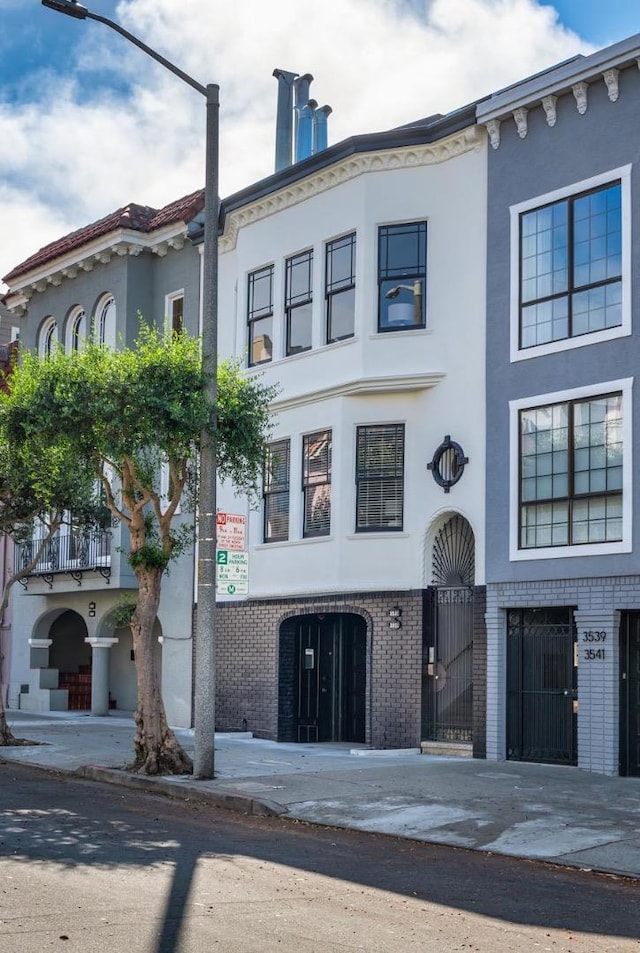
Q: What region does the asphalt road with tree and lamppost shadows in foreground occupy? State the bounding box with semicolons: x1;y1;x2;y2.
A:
0;759;640;953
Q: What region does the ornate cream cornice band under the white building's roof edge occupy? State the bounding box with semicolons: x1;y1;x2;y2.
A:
219;125;485;253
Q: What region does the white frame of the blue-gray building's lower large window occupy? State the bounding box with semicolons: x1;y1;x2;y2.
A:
509;377;633;562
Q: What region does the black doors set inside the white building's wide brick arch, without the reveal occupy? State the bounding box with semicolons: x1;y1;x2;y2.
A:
295;613;366;742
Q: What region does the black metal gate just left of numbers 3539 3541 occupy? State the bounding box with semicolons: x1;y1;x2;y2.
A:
507;607;578;765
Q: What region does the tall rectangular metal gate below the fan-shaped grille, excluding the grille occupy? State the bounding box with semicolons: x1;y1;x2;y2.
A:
422;586;473;742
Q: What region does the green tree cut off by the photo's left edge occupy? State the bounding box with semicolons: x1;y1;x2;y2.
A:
0;436;100;746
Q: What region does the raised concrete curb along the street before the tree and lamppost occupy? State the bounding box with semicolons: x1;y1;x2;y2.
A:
71;764;288;817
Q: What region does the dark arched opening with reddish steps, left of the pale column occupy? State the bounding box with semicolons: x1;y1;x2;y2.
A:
49;609;91;711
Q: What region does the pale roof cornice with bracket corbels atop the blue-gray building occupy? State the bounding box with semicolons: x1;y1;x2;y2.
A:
476;34;640;149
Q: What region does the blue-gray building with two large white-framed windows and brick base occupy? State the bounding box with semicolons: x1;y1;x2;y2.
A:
477;36;640;775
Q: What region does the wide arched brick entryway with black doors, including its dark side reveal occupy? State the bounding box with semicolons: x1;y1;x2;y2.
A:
278;612;367;742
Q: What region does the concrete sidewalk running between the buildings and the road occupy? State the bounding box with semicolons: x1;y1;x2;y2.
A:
0;711;640;878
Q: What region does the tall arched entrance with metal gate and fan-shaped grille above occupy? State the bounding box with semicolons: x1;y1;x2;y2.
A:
422;513;475;742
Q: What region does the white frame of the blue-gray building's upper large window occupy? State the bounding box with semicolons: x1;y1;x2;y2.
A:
509;165;631;364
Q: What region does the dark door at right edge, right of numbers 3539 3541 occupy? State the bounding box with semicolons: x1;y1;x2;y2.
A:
620;612;640;778
